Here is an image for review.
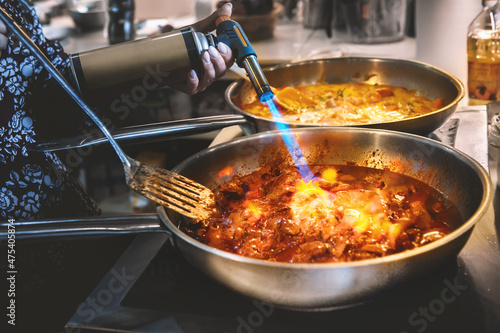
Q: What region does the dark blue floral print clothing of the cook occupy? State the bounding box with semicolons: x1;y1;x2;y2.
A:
0;0;99;220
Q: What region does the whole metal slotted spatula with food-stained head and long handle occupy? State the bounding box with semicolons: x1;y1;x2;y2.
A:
0;8;215;220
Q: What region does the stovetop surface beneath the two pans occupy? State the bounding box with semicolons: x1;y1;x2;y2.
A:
67;109;500;333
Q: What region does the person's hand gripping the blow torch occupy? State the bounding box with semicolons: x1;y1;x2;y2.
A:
172;3;234;95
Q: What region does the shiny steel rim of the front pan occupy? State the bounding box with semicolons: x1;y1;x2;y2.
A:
161;127;494;270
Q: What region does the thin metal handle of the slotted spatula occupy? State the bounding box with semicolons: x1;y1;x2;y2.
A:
0;7;131;168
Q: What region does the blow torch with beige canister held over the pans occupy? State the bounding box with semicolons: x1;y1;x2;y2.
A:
70;16;272;103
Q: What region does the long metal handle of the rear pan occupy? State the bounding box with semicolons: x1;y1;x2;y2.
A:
28;115;247;151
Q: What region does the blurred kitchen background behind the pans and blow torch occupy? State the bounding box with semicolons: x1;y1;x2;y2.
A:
22;0;482;214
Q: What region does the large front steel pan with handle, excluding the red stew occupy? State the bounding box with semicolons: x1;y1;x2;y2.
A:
0;128;493;311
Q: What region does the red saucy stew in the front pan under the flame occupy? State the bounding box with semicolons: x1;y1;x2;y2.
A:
183;163;463;263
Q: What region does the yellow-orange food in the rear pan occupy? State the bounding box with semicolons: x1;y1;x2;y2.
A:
236;83;443;126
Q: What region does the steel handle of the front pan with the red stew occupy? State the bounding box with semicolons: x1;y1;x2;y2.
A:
0;214;166;241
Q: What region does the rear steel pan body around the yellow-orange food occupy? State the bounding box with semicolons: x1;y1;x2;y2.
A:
225;57;465;135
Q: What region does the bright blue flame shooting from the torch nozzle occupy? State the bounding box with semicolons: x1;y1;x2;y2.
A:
260;92;315;183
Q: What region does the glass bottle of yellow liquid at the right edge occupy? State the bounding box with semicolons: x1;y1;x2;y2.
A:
467;0;500;105
